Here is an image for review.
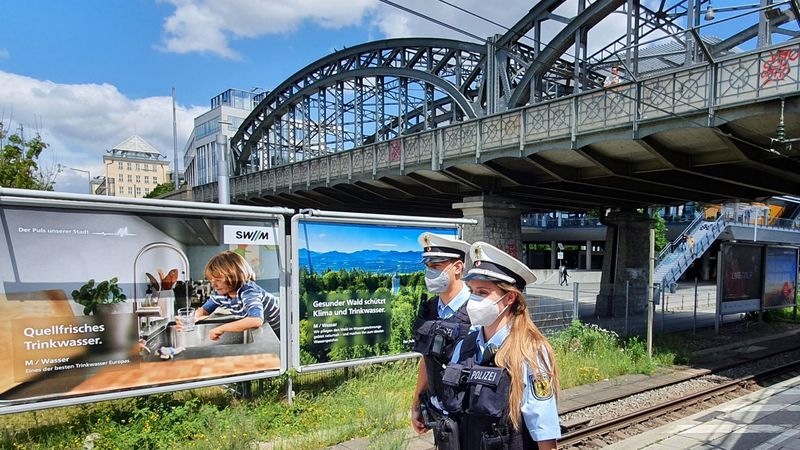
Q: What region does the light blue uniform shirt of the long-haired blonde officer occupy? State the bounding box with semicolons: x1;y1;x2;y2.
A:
451;326;561;441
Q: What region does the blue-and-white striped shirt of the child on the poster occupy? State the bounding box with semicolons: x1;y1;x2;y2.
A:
203;281;281;339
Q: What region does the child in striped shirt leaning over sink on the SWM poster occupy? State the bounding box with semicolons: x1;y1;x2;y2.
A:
176;250;281;340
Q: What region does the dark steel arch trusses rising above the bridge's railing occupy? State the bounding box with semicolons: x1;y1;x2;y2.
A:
222;0;800;213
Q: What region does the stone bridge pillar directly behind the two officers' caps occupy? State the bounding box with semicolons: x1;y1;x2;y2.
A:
453;195;524;260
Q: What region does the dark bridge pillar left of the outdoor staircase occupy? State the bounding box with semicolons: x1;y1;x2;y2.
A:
595;211;651;317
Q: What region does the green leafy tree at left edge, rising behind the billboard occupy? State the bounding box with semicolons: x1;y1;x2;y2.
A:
0;122;55;191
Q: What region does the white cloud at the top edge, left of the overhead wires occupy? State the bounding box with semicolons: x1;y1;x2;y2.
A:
164;0;376;59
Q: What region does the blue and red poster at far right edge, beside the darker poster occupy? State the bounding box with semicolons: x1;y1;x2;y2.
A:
764;246;797;309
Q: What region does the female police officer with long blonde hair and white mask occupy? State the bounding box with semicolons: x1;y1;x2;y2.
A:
443;242;561;450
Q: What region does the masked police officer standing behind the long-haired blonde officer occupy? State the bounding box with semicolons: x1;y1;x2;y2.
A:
411;232;470;434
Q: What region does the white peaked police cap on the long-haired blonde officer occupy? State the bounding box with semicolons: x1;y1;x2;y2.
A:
464;242;536;290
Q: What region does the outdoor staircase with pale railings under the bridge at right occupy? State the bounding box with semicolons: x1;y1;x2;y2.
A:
653;214;727;286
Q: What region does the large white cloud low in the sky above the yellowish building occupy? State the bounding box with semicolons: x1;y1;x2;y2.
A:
0;71;207;192
